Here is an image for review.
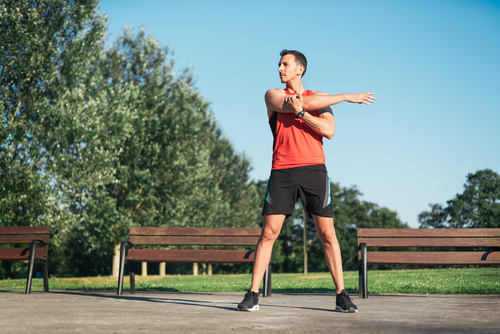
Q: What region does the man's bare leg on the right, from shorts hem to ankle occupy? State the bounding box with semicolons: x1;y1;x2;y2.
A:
312;215;344;294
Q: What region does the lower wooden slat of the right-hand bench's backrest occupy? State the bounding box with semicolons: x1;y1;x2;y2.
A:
358;237;500;247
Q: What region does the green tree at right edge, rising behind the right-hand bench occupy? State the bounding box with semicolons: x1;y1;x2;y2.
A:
418;169;500;228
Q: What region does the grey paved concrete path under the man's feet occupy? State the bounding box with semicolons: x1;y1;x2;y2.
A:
0;291;500;334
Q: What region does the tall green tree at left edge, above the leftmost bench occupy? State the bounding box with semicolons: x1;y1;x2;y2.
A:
0;0;103;225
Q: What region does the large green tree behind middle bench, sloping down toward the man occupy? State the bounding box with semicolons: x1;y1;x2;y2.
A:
100;28;259;274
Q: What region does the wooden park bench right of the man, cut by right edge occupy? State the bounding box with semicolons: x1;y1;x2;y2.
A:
358;228;500;298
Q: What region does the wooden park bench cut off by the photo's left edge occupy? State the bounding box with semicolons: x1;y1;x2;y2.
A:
0;226;50;293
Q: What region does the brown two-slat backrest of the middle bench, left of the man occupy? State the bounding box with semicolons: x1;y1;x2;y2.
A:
129;227;261;246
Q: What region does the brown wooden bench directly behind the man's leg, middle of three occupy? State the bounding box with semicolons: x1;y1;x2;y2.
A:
118;227;271;297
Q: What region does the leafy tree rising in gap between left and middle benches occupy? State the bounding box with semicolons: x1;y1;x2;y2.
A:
42;51;136;276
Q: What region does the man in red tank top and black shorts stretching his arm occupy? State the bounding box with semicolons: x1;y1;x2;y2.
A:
238;50;375;313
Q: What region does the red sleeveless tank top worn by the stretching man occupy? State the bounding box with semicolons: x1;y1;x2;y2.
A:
269;90;325;170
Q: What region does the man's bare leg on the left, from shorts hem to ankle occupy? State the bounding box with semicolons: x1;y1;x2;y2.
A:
250;215;286;293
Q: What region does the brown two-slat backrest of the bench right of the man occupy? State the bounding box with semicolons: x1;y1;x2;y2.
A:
358;228;500;247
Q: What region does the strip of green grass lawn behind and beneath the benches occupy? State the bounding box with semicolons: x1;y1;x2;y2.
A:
0;268;500;295
